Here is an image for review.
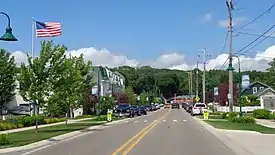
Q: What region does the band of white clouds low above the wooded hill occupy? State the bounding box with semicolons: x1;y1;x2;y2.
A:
9;45;275;71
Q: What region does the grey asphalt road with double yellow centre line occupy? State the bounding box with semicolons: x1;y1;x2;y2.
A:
3;109;237;155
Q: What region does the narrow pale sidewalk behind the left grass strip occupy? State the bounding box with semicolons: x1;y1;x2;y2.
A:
0;117;95;134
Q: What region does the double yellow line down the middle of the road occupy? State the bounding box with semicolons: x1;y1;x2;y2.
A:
112;109;171;155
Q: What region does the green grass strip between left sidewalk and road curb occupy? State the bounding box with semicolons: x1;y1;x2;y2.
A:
0;122;103;148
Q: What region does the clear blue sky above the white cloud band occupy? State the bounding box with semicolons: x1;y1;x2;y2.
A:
0;0;275;63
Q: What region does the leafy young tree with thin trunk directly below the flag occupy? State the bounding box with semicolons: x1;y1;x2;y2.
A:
18;41;57;133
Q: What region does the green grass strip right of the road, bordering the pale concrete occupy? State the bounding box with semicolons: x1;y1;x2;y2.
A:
205;120;275;134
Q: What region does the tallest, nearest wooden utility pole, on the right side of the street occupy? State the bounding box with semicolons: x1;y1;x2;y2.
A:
226;0;234;112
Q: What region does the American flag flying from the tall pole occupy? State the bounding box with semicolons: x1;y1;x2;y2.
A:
35;21;62;38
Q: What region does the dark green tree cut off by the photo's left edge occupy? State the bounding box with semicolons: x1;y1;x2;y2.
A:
0;49;16;119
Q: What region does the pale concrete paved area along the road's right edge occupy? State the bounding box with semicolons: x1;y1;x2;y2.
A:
194;118;275;155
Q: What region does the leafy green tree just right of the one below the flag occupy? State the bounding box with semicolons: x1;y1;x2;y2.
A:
50;51;92;123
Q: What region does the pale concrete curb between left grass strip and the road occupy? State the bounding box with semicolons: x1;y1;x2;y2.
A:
0;110;163;153
